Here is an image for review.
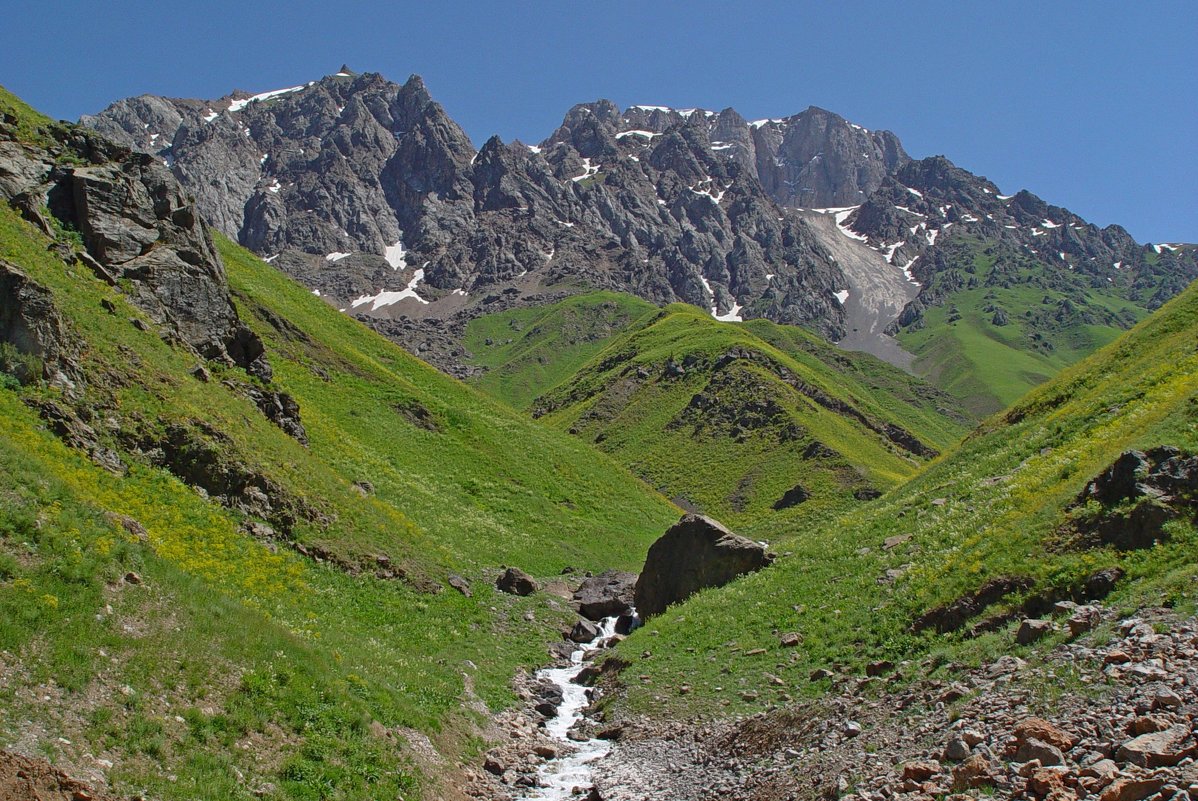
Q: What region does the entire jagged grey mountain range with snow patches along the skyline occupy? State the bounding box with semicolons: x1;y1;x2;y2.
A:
84;68;1198;365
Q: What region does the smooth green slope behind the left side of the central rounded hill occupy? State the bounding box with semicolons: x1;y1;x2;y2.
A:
465;292;657;408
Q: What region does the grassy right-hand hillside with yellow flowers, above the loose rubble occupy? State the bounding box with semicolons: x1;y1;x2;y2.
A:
608;270;1198;714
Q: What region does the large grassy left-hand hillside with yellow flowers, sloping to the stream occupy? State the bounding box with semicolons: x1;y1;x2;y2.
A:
0;86;677;799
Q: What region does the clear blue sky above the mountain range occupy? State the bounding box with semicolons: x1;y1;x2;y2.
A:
0;0;1198;242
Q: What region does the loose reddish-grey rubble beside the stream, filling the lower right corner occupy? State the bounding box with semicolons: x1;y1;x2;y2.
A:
470;602;1198;801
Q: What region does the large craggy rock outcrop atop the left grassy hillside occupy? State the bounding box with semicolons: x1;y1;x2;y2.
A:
0;118;268;378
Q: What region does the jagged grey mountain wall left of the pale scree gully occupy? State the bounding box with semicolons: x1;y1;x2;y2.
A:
84;71;907;339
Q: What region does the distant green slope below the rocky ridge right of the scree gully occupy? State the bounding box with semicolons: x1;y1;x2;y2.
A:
899;235;1148;415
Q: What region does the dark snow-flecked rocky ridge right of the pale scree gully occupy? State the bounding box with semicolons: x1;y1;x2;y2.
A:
841;156;1198;326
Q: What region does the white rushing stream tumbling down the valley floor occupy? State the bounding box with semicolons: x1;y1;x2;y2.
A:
518;618;616;801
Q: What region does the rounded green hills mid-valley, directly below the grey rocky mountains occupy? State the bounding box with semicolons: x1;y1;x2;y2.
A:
481;293;967;538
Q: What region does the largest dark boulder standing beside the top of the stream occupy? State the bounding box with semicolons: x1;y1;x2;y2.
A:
633;515;773;618
